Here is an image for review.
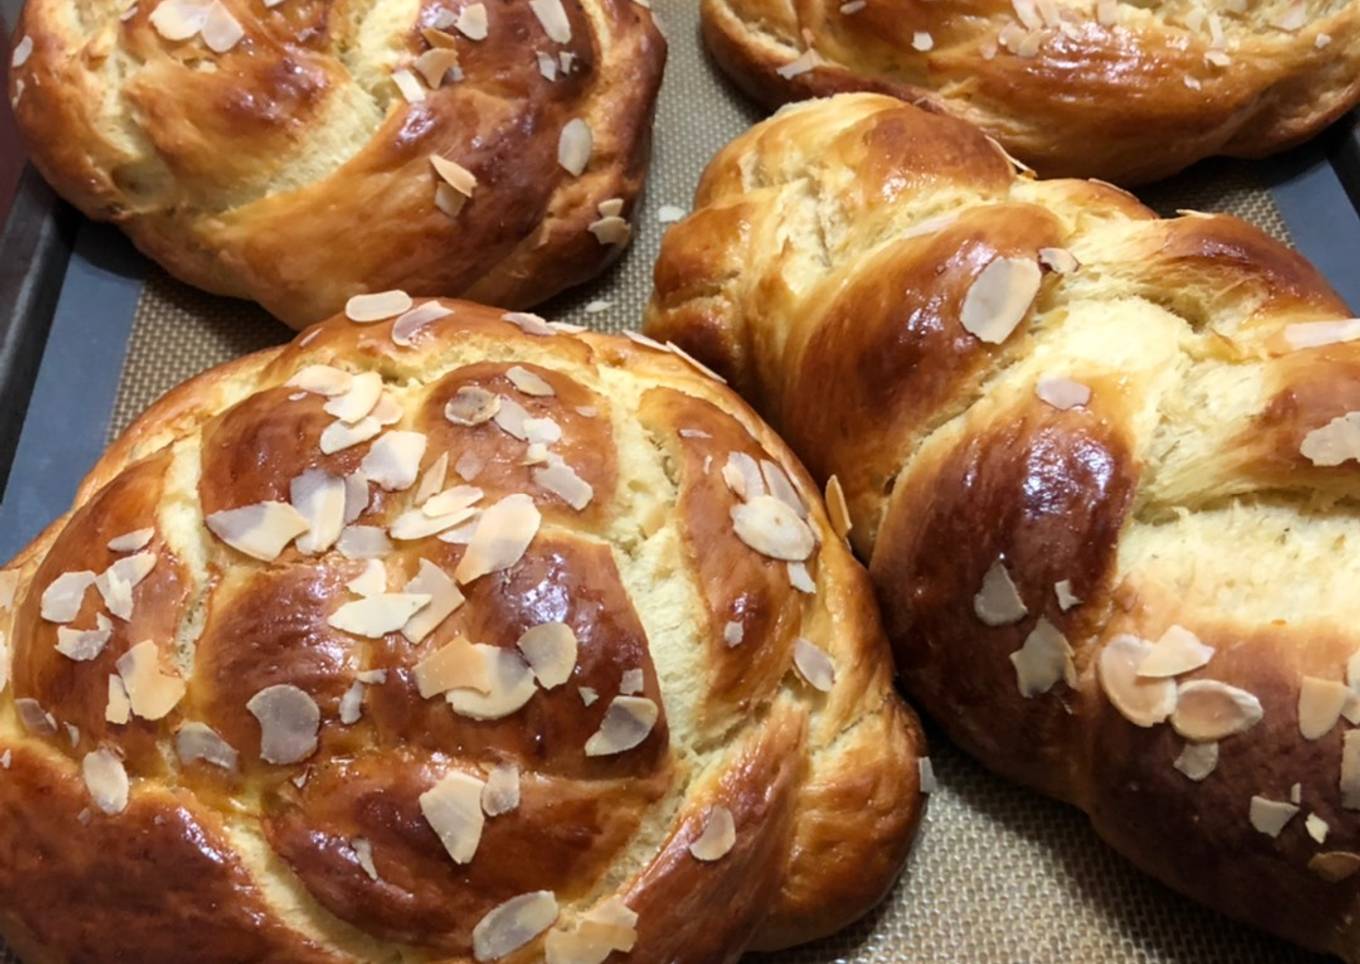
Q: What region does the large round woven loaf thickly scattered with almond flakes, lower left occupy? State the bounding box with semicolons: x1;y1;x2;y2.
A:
0;294;929;964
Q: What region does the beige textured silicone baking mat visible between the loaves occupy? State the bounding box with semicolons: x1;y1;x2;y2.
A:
95;0;1316;964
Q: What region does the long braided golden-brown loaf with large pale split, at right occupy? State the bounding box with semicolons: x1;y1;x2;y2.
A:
649;94;1360;960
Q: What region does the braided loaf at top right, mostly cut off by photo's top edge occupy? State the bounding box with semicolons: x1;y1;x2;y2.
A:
702;0;1360;184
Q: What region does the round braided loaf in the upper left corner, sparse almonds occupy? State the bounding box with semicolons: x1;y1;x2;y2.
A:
10;0;665;328
